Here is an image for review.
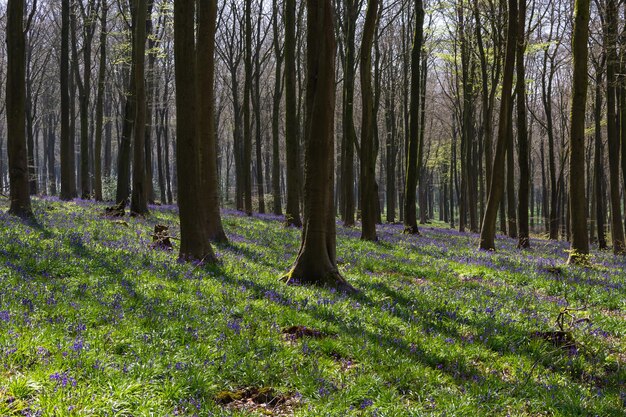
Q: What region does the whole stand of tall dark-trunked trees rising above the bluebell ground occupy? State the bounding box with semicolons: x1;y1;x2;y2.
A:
0;0;612;285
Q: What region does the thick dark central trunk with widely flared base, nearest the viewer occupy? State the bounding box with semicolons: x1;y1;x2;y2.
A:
284;0;353;291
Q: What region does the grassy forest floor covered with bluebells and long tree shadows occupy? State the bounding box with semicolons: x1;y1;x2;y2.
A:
0;198;626;416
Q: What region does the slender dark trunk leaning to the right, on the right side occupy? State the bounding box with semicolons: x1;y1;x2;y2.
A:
479;0;517;250
